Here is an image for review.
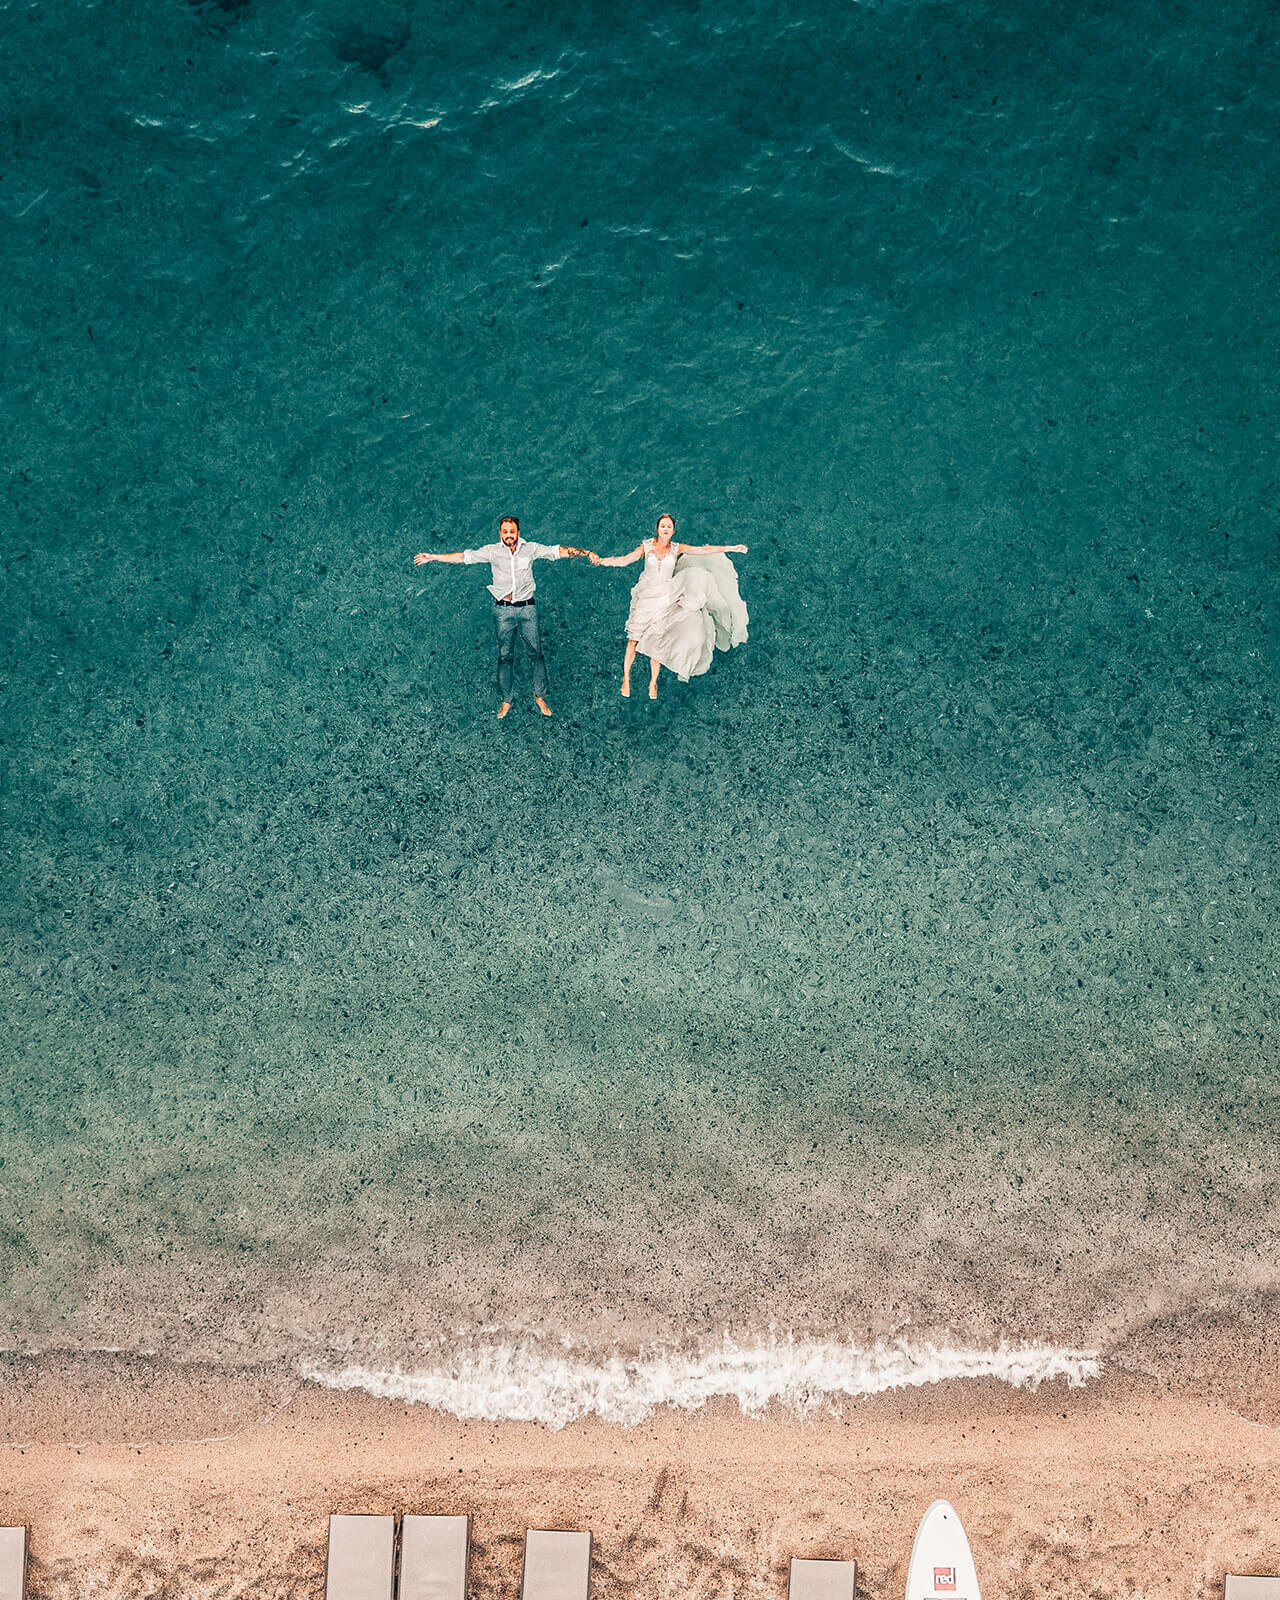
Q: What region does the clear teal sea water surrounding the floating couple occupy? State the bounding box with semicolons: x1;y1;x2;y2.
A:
0;0;1280;1410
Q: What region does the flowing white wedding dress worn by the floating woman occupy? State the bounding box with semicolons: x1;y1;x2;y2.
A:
627;539;747;683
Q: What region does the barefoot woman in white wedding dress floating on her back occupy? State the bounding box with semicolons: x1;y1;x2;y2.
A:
590;515;747;699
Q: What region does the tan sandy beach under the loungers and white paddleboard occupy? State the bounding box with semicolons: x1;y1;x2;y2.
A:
0;1337;1280;1600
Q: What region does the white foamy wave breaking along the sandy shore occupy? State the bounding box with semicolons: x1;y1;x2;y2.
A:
302;1341;1099;1429
